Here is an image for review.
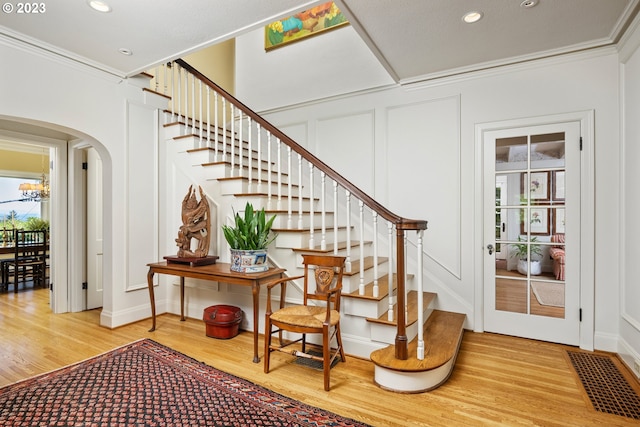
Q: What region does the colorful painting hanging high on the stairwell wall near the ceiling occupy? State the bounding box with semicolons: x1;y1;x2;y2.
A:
264;1;349;50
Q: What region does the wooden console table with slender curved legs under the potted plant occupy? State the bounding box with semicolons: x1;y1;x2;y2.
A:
147;262;285;363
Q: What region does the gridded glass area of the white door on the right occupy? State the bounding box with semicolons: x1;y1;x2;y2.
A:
495;133;566;318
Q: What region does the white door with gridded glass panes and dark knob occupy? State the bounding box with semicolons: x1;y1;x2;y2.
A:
483;121;580;345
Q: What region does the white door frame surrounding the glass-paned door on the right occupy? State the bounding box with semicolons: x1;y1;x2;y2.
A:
474;110;595;350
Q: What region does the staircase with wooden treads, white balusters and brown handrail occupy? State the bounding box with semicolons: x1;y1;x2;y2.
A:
150;60;465;392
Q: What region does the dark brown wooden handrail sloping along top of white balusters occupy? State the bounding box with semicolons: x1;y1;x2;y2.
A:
175;59;427;230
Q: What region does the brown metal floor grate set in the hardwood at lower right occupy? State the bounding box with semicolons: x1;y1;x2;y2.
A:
567;351;640;420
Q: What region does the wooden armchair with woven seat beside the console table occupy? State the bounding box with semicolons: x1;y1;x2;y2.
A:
264;255;346;391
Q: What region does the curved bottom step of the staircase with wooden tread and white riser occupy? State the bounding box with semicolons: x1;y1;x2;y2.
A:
371;310;465;393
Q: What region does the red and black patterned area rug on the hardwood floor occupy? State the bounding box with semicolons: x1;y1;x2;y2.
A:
0;339;366;427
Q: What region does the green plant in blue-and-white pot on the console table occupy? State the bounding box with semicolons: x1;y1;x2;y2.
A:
222;203;276;273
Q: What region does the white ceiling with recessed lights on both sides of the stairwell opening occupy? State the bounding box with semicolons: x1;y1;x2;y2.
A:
0;0;640;83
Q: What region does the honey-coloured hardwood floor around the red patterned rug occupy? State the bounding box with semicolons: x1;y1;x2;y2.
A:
0;289;638;427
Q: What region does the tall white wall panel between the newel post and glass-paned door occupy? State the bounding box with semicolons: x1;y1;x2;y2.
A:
386;96;461;278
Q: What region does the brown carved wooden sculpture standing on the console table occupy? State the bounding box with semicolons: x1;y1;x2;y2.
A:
176;186;211;258
